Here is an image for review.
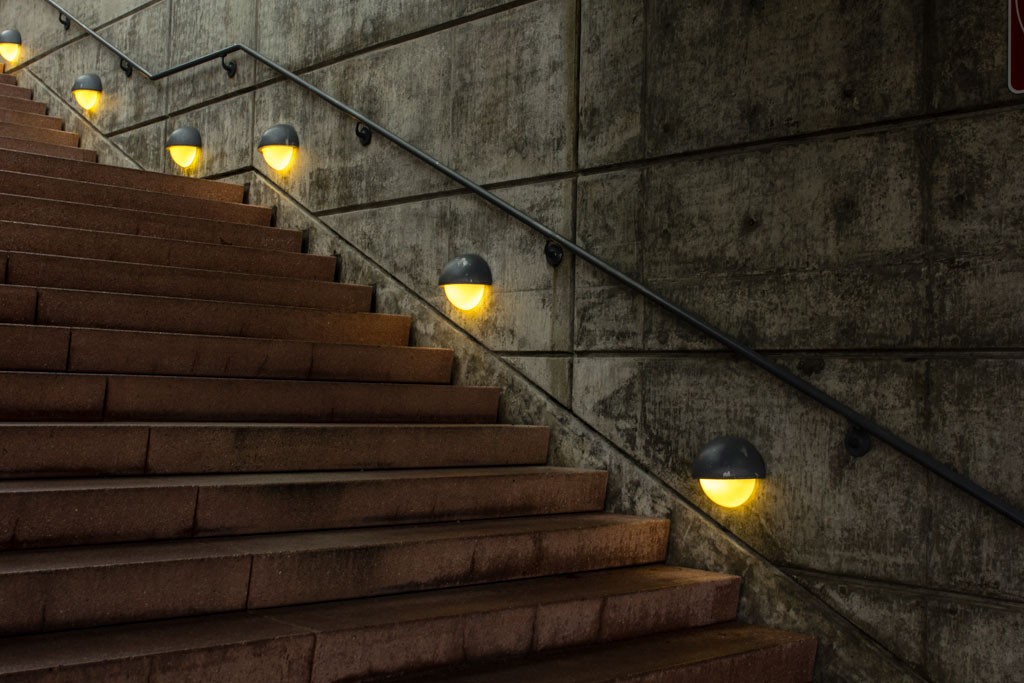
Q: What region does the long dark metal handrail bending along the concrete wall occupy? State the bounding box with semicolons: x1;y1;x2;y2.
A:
34;0;1024;526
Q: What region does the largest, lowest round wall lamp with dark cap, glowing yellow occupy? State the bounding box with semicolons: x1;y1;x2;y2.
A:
692;436;766;508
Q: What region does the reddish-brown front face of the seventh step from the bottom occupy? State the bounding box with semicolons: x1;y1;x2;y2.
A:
0;324;453;384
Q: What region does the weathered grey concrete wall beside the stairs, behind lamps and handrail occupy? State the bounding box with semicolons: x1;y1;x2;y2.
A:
0;0;1024;682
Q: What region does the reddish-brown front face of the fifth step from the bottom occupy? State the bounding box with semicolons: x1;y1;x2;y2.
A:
0;423;550;478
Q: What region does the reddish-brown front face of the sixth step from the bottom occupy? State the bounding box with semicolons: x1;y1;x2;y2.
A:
0;372;500;424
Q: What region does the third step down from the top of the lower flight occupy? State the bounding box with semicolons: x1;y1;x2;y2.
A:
0;193;302;252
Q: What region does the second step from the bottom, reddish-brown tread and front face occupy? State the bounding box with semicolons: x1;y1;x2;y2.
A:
0;565;739;683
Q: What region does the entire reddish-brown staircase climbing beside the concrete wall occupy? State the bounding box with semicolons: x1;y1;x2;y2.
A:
0;61;815;683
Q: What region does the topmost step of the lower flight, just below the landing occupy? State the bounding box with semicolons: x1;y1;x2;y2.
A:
0;148;245;203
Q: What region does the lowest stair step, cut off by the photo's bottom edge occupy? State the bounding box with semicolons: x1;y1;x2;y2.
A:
388;624;817;683
